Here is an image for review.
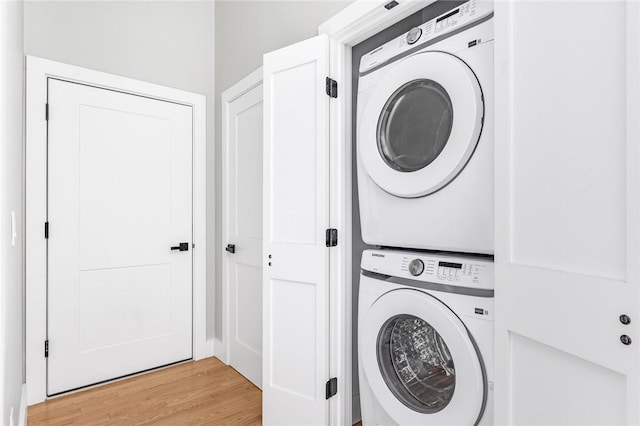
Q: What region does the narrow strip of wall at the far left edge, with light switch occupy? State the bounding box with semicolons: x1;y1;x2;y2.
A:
0;1;24;425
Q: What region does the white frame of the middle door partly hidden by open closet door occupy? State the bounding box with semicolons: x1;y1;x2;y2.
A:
215;67;262;364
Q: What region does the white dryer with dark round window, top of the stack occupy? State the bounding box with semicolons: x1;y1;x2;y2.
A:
357;0;493;254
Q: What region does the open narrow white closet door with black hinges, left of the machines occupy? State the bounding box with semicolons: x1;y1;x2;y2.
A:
262;35;329;425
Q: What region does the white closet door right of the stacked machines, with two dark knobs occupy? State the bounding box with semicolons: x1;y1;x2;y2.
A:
495;1;640;425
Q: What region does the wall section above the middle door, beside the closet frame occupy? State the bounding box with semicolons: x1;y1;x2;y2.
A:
209;0;351;338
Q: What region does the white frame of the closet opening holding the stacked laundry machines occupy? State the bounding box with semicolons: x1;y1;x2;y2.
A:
318;0;436;424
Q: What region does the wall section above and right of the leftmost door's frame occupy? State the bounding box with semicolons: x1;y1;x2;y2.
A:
25;0;215;337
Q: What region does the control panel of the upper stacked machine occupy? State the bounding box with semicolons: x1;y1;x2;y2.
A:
360;0;493;73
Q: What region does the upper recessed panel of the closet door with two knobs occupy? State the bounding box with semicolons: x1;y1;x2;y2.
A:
508;2;627;280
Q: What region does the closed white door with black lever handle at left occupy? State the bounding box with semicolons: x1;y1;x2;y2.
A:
47;79;192;395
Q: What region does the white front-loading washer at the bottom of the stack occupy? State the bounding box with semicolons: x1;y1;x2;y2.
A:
358;250;494;426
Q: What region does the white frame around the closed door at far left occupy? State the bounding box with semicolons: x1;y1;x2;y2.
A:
25;56;209;405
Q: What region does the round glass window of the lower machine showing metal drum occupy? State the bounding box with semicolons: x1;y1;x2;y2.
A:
377;315;456;414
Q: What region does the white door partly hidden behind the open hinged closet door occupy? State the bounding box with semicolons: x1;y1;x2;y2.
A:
222;70;262;388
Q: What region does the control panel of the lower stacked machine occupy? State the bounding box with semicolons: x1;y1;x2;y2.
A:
361;250;494;290
